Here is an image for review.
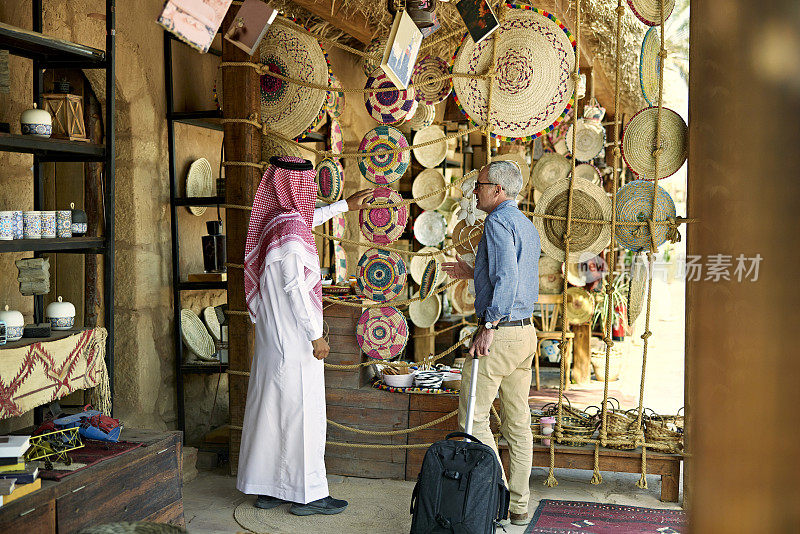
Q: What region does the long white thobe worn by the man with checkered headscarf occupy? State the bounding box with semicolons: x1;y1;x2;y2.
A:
236;200;347;504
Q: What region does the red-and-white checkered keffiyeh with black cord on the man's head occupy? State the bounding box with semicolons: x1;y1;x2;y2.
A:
244;156;322;323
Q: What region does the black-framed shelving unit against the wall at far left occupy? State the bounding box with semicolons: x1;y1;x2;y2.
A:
0;0;116;407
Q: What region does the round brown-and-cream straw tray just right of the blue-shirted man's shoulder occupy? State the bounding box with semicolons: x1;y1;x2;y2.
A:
533;178;611;262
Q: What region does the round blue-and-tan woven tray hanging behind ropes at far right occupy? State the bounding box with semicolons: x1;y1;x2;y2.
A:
616;180;675;251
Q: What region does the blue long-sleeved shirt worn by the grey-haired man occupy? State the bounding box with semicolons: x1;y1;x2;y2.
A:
475;200;541;322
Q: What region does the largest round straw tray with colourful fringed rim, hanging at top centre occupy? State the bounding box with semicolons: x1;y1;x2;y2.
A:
453;6;575;140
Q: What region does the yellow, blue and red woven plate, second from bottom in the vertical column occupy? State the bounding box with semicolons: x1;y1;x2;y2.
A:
356;248;406;302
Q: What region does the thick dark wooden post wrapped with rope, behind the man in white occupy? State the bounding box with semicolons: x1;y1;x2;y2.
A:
222;10;261;474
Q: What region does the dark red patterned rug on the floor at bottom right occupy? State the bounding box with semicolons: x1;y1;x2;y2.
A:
525;499;686;534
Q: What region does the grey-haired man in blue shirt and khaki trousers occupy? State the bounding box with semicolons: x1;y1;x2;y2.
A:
443;161;541;525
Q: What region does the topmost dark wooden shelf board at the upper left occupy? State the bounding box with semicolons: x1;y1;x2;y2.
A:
0;22;106;69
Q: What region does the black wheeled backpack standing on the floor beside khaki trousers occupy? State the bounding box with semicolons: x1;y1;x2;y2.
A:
411;432;510;534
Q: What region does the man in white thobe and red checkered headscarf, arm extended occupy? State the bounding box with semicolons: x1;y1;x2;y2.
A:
236;156;370;515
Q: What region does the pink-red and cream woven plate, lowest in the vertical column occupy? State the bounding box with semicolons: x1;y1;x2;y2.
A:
356;306;408;360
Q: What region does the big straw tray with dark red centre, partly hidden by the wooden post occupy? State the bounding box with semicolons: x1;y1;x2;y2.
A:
258;24;328;140
